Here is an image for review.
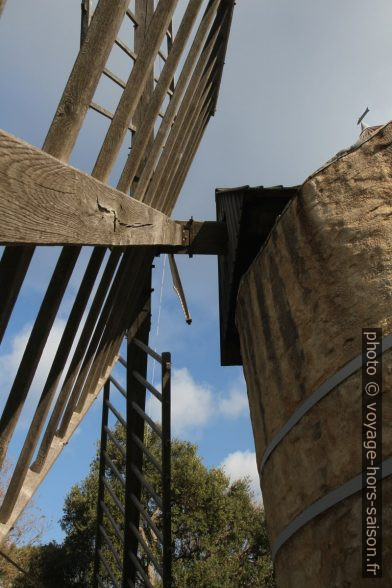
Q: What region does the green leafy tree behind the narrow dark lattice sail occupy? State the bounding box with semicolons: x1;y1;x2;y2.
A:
9;427;275;588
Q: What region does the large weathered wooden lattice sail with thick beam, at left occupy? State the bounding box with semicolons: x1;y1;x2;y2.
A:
0;0;234;541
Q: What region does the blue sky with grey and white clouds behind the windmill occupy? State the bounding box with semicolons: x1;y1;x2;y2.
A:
0;0;392;539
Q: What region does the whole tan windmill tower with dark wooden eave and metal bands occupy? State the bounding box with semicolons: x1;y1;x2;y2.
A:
216;123;392;588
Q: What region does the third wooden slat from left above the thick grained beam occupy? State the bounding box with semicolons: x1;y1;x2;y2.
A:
118;0;202;192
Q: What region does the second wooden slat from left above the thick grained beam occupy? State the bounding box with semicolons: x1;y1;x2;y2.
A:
93;0;178;181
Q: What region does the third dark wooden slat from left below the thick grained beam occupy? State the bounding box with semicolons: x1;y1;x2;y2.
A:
0;248;105;523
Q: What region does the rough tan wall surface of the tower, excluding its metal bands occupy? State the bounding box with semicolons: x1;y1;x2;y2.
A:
236;123;392;588
